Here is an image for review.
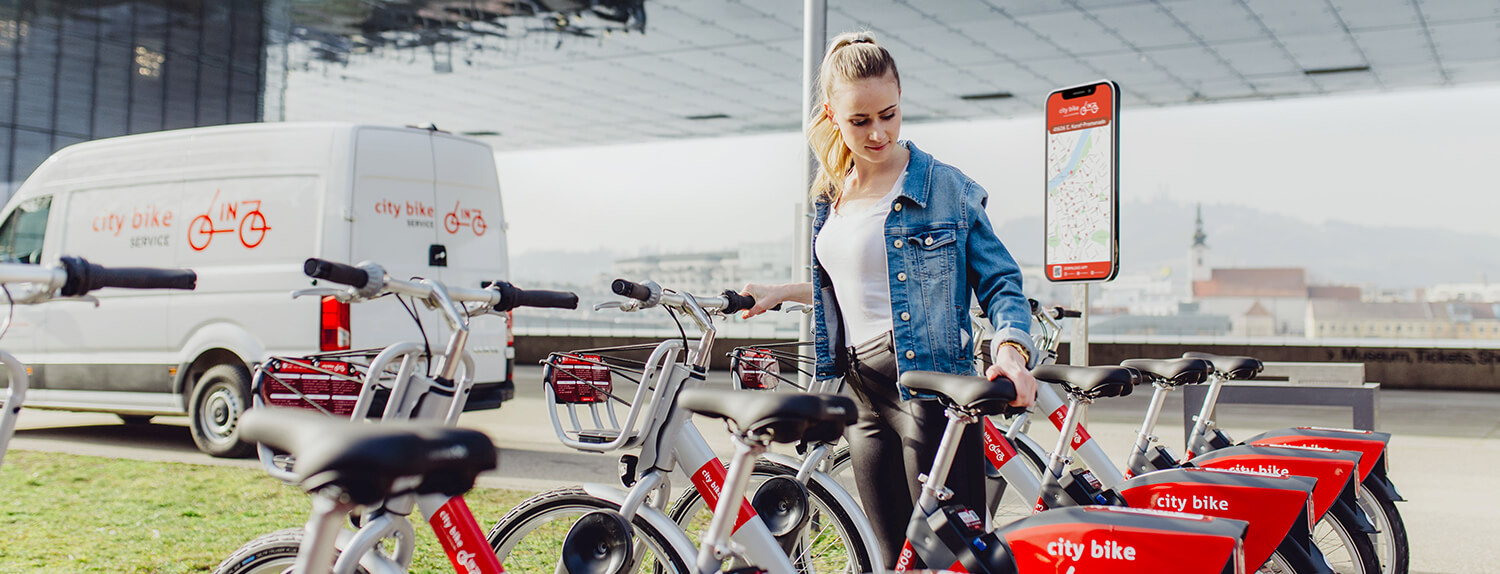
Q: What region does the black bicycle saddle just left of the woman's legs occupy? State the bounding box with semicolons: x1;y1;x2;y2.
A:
677;388;857;442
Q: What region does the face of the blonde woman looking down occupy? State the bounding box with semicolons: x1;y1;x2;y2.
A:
828;72;902;163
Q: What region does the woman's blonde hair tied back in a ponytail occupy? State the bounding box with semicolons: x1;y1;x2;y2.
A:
807;31;902;202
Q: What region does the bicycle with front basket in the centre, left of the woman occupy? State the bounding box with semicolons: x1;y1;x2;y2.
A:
489;279;872;574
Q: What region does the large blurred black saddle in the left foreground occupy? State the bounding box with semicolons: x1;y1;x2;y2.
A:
240;406;498;504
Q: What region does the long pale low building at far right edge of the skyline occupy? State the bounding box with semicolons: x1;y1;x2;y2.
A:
1307;300;1500;340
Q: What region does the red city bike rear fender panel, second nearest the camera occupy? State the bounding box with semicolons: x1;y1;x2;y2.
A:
1115;469;1317;567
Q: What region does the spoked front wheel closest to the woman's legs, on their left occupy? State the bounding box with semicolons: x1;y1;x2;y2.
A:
668;460;875;573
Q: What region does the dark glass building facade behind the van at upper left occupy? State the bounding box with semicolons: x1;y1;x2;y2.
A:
0;0;270;198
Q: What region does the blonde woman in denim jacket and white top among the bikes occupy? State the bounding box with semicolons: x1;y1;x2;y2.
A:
744;33;1037;567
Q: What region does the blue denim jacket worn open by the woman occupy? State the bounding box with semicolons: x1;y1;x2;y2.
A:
813;142;1038;389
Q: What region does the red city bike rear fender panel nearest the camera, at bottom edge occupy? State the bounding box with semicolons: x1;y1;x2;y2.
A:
996;507;1245;574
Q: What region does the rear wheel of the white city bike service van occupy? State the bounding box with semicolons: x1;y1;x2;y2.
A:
188;364;255;459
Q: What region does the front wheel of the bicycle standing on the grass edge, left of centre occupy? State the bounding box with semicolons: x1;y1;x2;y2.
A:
489;487;693;574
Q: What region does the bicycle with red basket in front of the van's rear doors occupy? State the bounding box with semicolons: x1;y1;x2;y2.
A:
216;259;578;574
